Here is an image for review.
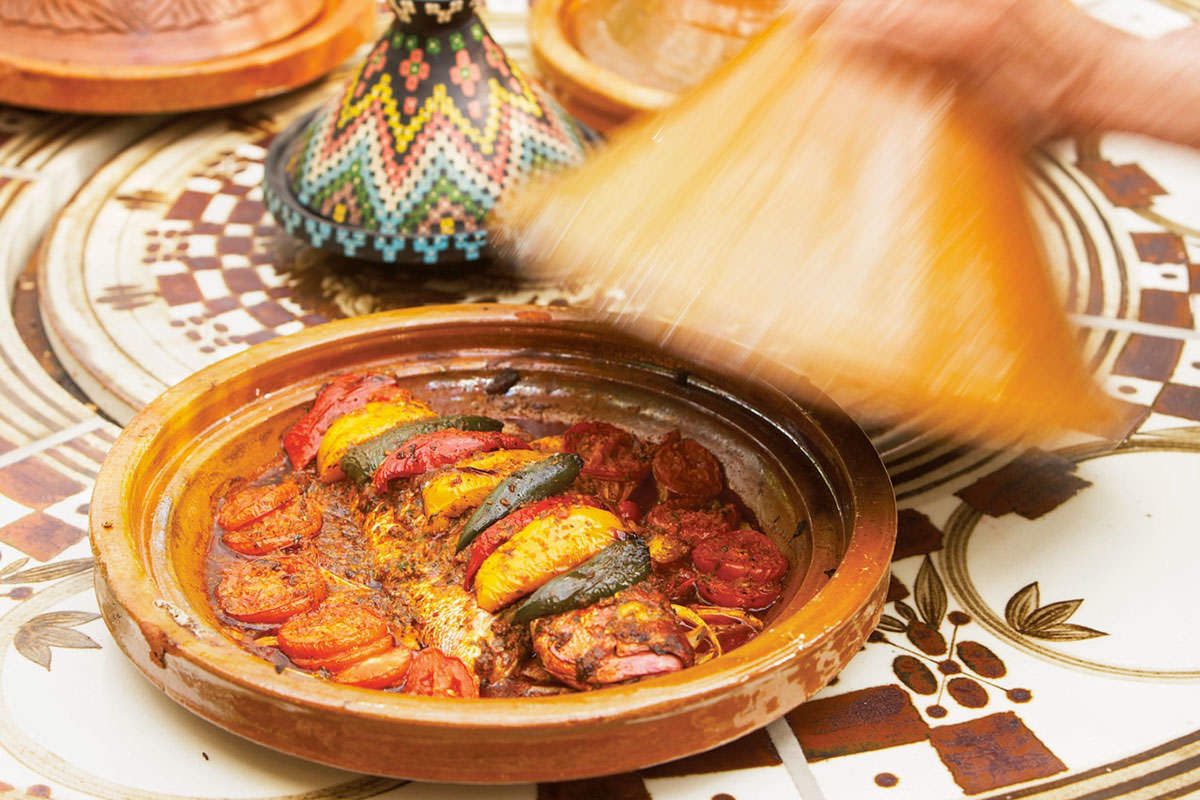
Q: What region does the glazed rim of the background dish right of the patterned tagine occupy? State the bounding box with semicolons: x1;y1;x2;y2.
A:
529;0;678;114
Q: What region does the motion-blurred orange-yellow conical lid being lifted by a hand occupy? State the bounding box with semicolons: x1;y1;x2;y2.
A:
497;23;1115;443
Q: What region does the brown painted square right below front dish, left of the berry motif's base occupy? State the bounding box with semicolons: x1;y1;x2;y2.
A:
786;684;929;760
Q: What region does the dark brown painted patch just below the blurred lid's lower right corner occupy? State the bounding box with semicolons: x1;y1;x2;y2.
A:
955;449;1091;519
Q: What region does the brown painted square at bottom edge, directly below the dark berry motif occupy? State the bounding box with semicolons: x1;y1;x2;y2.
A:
929;711;1067;794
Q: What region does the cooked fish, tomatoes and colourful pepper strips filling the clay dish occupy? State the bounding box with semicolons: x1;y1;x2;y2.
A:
209;374;790;697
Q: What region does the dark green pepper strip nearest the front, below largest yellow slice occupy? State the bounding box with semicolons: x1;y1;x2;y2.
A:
512;536;650;624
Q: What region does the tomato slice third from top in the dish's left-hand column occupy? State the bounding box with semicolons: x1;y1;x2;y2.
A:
214;557;326;625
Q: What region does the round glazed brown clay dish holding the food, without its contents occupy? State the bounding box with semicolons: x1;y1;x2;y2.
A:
91;306;896;782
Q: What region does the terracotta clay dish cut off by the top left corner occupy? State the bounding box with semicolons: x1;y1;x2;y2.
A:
0;0;376;114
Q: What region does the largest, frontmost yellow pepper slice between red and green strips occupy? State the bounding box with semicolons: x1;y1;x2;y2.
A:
475;505;624;613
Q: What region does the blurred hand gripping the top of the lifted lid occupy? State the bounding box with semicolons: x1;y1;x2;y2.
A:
799;0;1142;142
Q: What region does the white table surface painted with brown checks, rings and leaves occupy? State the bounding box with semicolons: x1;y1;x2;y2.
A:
0;0;1200;800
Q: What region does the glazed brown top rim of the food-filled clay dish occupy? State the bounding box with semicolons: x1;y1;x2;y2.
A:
89;305;896;734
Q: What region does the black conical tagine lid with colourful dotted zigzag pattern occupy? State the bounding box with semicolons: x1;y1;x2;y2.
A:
264;0;592;264
